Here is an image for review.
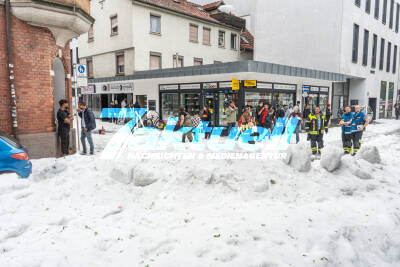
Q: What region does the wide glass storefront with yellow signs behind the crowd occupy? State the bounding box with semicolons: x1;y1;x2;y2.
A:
159;81;297;126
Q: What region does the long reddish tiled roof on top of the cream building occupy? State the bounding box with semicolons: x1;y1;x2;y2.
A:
135;0;221;24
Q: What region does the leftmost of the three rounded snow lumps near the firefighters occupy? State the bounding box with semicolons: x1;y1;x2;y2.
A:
285;142;311;172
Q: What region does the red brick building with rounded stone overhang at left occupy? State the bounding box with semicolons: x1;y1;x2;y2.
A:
0;0;93;158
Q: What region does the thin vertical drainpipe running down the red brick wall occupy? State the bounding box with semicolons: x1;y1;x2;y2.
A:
6;0;18;139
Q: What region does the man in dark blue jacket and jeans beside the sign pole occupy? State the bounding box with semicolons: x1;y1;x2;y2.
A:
77;102;96;155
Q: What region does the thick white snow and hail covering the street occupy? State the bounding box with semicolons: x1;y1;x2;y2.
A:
0;120;400;267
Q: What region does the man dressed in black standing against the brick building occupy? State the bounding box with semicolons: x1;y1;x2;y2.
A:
57;99;73;157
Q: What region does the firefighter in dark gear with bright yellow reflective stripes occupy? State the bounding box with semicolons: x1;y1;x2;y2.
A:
305;107;328;155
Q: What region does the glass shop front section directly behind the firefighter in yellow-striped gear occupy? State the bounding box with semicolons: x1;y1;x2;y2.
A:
303;85;329;112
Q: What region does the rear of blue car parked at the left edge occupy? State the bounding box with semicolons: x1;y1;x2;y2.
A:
0;131;32;178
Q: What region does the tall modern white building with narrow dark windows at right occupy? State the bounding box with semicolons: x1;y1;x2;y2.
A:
209;0;400;117
